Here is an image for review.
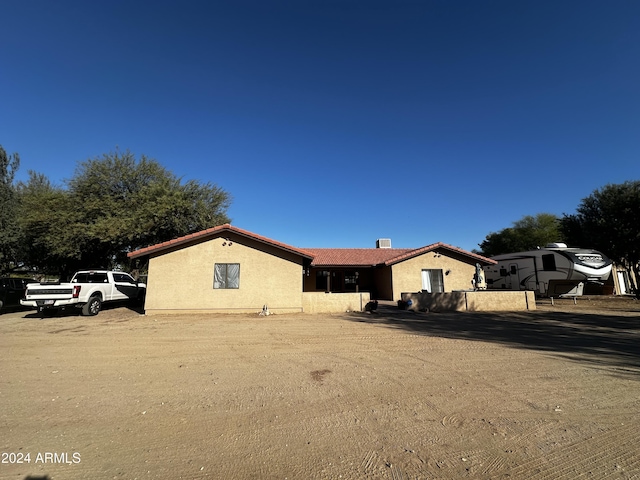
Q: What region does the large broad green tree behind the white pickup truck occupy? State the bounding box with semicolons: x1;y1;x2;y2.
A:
20;151;230;275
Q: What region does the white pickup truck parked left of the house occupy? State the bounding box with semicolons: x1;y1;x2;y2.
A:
20;270;147;315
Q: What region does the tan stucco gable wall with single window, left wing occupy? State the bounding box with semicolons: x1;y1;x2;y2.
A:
145;233;302;314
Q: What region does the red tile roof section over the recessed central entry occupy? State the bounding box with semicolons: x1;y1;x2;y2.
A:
305;248;412;267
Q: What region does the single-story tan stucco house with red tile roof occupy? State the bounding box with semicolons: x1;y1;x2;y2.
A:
128;224;495;313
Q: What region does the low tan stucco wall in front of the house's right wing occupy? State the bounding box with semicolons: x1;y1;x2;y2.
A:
402;291;536;312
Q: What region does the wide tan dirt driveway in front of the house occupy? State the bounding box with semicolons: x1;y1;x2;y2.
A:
0;299;640;480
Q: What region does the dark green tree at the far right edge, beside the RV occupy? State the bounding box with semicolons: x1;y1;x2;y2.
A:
560;180;640;294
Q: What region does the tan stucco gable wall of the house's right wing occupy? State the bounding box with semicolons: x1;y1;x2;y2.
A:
391;250;476;300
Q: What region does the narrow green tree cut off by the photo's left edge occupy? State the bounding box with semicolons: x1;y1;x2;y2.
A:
0;145;20;274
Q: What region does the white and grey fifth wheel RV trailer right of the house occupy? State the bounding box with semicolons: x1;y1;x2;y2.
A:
485;243;611;297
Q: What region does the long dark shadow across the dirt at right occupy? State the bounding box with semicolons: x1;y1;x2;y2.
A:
345;305;640;379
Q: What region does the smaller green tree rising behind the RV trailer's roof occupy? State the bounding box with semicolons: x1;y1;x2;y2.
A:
479;213;562;257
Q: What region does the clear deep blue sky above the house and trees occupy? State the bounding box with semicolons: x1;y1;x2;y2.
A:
0;0;640;250
